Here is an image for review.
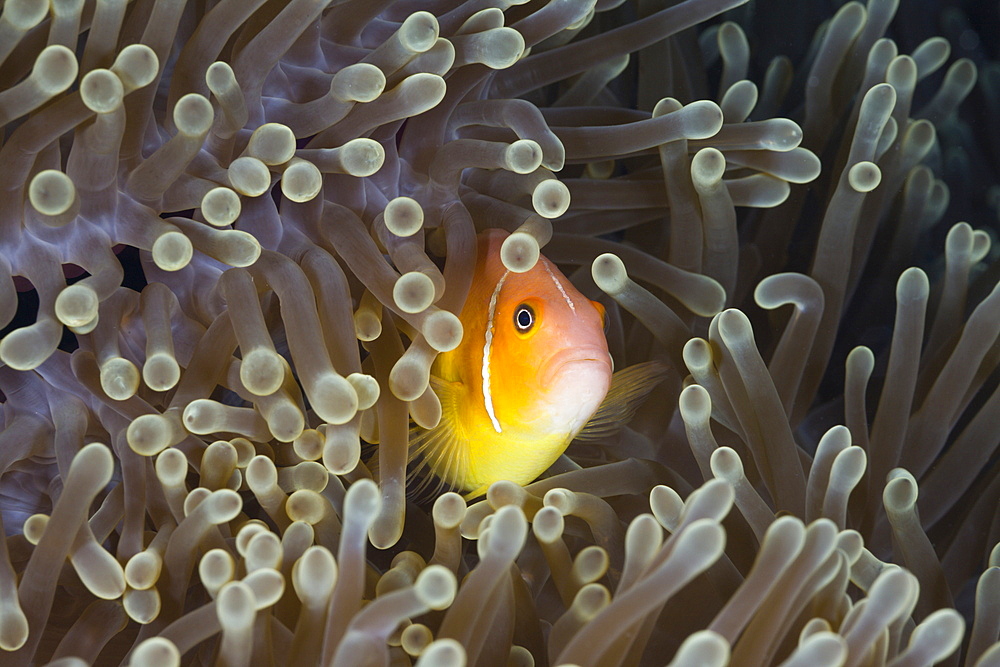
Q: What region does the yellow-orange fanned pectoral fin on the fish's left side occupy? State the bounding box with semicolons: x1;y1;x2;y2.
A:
408;376;469;495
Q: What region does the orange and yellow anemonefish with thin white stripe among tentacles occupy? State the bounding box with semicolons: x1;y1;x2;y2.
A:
410;229;664;498
